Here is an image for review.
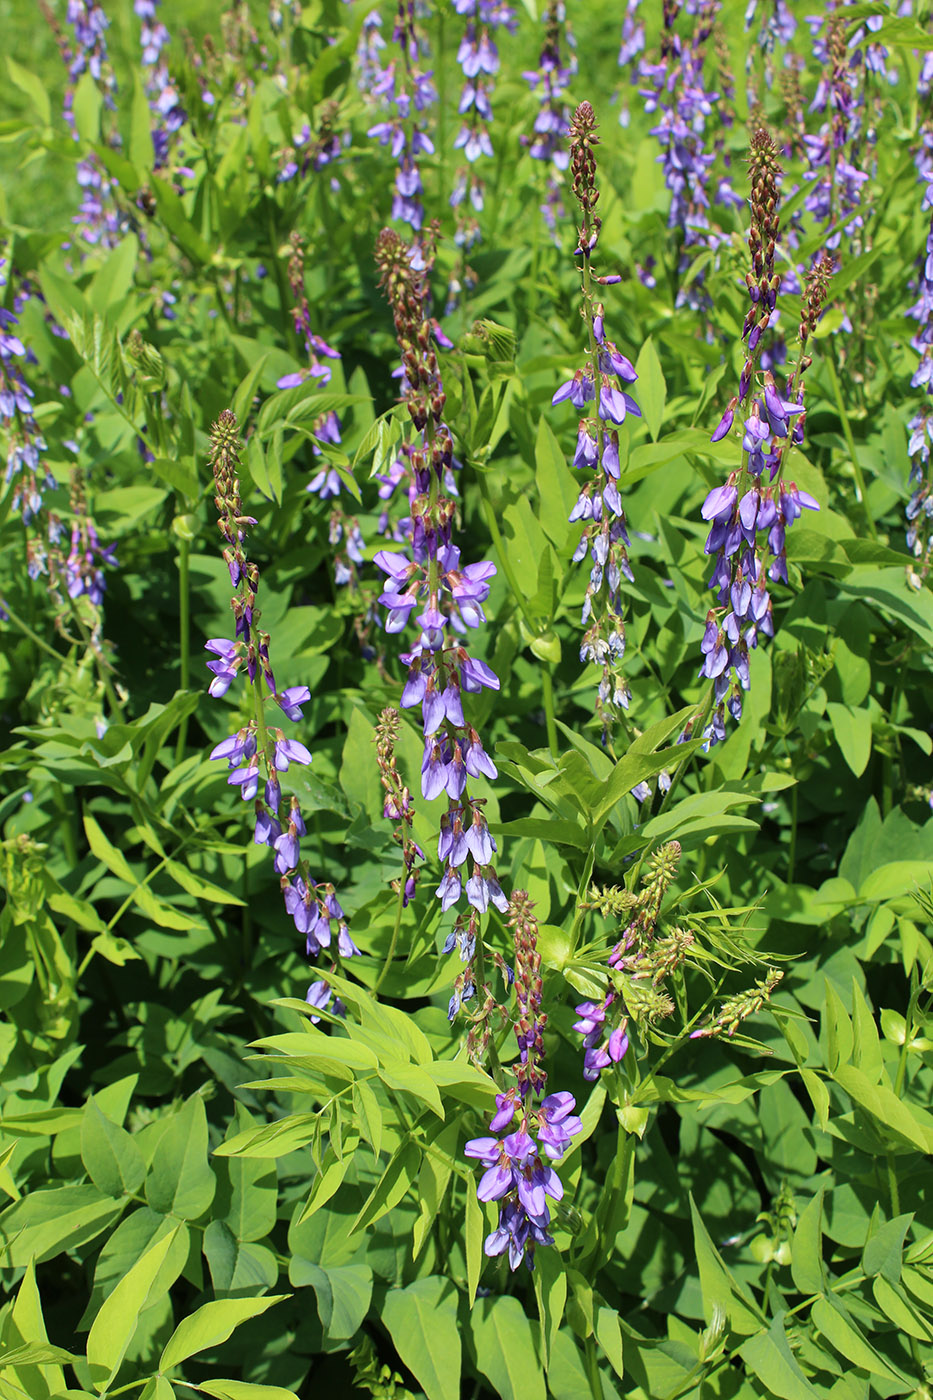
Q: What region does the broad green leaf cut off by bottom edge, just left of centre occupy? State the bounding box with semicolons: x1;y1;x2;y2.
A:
382;1278;461;1400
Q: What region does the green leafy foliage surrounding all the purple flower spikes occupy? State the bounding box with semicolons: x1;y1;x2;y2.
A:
0;0;933;1400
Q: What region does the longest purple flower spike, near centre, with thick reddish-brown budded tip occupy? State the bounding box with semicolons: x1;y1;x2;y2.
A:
375;228;506;1015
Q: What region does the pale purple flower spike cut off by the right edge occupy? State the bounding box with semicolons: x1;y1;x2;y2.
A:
906;174;933;588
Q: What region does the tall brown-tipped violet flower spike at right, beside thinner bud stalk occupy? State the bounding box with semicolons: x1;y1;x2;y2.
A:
700;130;828;743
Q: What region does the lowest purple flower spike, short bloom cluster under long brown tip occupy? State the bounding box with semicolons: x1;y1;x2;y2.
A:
464;890;583;1273
